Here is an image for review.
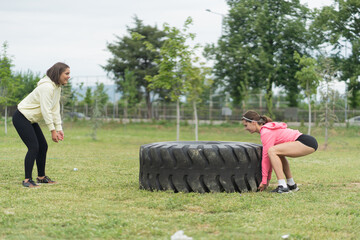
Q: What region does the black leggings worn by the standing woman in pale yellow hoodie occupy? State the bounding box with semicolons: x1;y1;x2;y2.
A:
12;110;48;178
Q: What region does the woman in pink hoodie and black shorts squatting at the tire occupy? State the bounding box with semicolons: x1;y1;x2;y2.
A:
242;111;318;193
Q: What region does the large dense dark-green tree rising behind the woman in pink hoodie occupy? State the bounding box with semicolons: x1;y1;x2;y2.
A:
210;0;309;116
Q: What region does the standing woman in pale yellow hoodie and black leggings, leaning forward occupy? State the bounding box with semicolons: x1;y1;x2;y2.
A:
13;62;70;187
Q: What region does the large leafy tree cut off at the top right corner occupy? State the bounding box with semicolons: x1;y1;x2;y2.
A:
311;0;360;108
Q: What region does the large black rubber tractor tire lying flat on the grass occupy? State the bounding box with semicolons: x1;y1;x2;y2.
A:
139;142;262;193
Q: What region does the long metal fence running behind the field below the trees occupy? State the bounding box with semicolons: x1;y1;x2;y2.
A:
0;103;360;122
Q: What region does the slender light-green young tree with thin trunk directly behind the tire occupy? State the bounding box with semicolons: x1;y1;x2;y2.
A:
145;17;196;141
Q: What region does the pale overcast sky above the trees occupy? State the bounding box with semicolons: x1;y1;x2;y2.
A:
0;0;338;89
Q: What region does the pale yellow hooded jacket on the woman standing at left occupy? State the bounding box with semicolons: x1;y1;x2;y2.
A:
18;76;62;131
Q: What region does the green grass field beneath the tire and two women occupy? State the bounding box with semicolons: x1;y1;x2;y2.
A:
0;121;360;240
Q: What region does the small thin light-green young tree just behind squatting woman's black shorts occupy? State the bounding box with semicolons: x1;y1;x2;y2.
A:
294;52;321;135
